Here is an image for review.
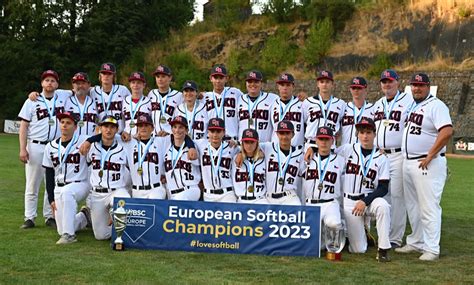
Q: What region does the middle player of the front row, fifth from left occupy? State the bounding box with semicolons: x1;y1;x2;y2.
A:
194;117;237;203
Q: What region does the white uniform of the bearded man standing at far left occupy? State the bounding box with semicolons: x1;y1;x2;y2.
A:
18;90;67;220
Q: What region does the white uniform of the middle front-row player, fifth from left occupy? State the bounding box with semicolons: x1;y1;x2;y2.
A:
196;139;238;203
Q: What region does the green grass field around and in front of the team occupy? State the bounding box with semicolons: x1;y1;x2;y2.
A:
0;135;474;284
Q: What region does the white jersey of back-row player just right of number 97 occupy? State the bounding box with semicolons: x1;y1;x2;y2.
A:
271;96;304;146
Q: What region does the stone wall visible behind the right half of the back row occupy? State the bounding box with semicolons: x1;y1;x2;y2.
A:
265;71;474;139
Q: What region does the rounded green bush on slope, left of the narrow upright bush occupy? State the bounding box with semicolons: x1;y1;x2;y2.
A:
260;28;298;79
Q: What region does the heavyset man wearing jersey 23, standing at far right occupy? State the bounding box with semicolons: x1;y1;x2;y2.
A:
396;73;453;261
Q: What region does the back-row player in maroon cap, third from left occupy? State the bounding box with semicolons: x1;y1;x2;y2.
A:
91;63;130;134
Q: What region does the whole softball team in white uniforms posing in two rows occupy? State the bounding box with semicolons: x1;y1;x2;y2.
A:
19;63;453;262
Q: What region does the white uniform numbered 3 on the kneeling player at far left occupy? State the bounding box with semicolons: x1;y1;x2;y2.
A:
43;134;91;235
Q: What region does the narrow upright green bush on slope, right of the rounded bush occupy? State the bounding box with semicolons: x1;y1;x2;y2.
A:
303;18;334;67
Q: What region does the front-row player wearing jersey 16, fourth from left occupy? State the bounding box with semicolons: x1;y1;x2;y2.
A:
164;116;201;201
